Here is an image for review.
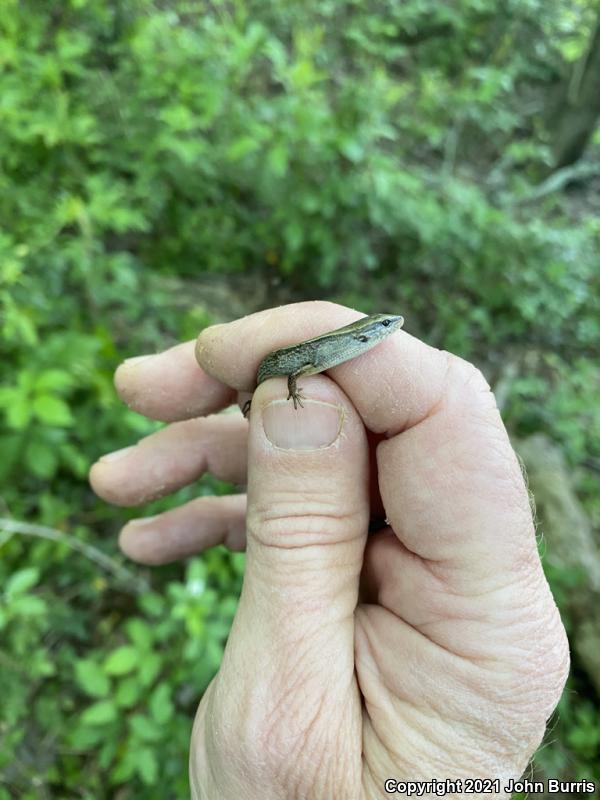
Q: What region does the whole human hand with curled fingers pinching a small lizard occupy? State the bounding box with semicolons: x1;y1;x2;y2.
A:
91;303;569;800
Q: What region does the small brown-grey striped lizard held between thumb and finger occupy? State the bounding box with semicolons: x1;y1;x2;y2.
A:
242;314;404;417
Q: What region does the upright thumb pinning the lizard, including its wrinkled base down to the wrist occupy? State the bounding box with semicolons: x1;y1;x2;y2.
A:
194;376;369;798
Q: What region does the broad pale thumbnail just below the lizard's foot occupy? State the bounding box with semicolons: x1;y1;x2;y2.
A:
262;400;344;450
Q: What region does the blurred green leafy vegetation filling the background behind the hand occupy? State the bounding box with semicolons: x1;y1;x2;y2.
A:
0;0;600;800
